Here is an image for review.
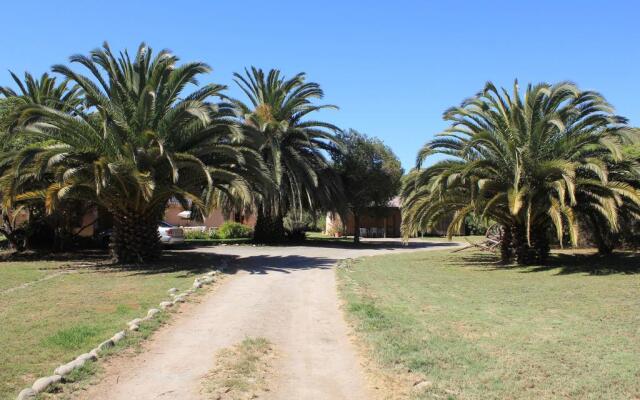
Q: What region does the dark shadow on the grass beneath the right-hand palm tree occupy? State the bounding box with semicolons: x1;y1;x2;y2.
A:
452;252;640;276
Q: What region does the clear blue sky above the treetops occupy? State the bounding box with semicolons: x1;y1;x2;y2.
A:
0;0;640;168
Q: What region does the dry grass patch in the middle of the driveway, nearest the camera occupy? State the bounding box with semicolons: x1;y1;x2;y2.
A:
202;338;275;400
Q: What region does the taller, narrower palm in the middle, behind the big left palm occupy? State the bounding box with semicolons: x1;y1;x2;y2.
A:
233;67;343;242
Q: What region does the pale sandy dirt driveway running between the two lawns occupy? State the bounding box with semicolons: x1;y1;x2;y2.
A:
78;241;460;400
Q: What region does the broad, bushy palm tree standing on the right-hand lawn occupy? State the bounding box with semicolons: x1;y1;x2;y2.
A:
403;81;640;264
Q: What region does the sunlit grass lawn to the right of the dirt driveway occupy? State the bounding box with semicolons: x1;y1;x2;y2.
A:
338;250;640;399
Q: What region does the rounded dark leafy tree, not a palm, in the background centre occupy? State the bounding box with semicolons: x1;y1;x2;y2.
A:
334;129;404;243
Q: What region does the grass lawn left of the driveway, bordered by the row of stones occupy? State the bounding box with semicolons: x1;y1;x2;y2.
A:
0;254;219;399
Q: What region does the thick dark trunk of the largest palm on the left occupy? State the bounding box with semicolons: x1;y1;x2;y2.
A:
111;210;162;264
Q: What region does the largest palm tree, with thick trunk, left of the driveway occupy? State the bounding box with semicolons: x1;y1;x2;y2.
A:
9;43;261;263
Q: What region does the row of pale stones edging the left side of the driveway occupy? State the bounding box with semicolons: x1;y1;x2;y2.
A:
14;260;226;400
